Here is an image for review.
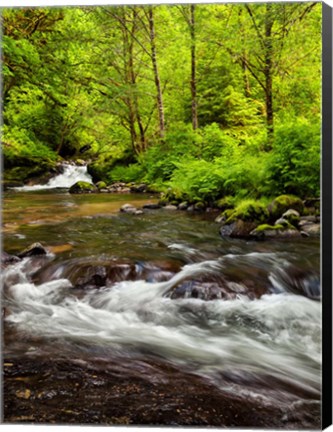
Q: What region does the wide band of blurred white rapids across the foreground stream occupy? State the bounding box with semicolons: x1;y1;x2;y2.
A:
3;253;321;399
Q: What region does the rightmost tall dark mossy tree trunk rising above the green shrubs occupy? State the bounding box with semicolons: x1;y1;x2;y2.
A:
264;3;274;150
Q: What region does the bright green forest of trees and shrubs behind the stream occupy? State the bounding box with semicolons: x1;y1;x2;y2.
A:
2;2;322;202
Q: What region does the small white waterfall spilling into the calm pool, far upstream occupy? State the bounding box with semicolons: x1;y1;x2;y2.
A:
13;164;92;191
